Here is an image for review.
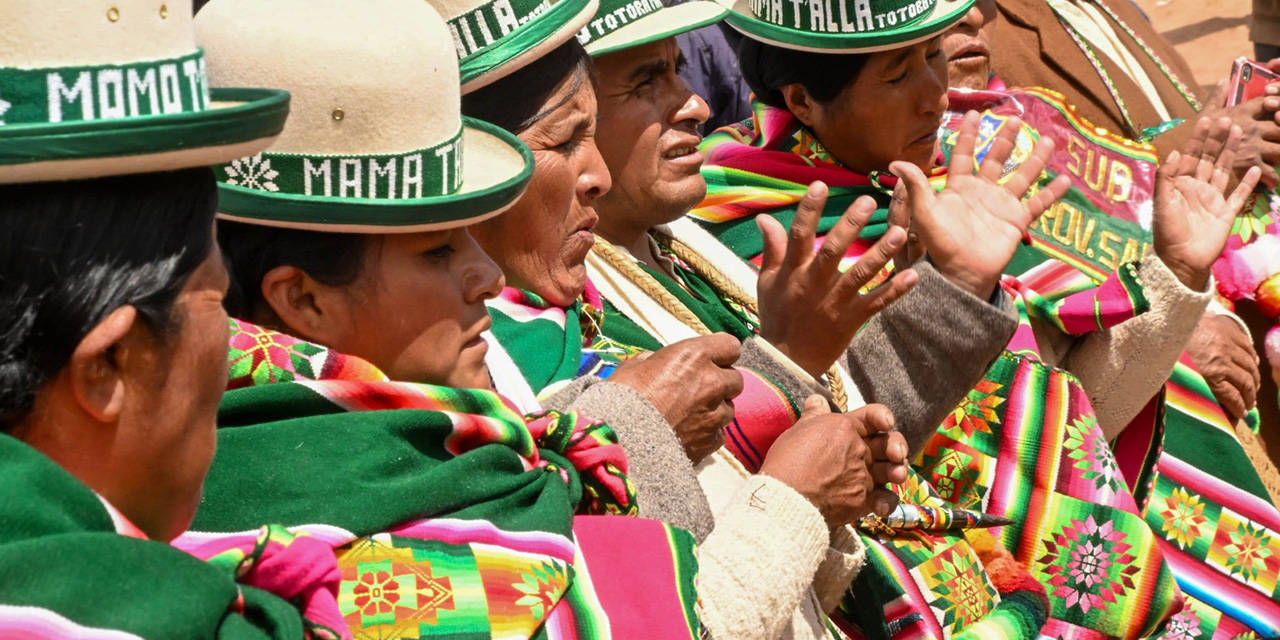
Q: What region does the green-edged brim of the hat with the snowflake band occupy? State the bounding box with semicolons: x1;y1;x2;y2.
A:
218;118;534;234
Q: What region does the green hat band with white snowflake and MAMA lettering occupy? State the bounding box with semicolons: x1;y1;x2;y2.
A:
214;124;462;200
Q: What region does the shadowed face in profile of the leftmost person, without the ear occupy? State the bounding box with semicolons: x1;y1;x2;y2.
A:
113;243;230;541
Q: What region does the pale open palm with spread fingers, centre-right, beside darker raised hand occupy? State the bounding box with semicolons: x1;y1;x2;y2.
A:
890;111;1070;300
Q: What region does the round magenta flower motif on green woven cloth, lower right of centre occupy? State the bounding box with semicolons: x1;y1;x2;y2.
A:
1038;516;1138;613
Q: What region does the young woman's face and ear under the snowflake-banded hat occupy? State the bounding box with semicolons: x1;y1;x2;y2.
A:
262;228;504;389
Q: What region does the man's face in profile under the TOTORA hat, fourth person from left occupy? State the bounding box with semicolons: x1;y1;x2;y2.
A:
595;38;710;234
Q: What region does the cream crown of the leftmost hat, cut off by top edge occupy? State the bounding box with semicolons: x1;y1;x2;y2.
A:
0;0;196;69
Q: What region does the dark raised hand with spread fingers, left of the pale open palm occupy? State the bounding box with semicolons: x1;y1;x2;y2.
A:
755;182;919;378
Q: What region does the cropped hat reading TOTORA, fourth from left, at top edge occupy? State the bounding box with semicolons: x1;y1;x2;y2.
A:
577;0;728;56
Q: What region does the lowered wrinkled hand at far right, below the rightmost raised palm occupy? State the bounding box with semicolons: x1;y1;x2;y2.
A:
1187;312;1262;421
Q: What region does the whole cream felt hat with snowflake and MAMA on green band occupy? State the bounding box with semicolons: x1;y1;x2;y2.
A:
196;0;532;233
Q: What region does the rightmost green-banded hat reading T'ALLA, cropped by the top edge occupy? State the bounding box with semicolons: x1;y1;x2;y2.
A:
723;0;974;54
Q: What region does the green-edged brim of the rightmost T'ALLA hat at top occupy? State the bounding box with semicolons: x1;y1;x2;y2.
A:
724;0;974;54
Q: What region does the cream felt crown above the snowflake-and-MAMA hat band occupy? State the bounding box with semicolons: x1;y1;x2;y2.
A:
196;0;462;156
